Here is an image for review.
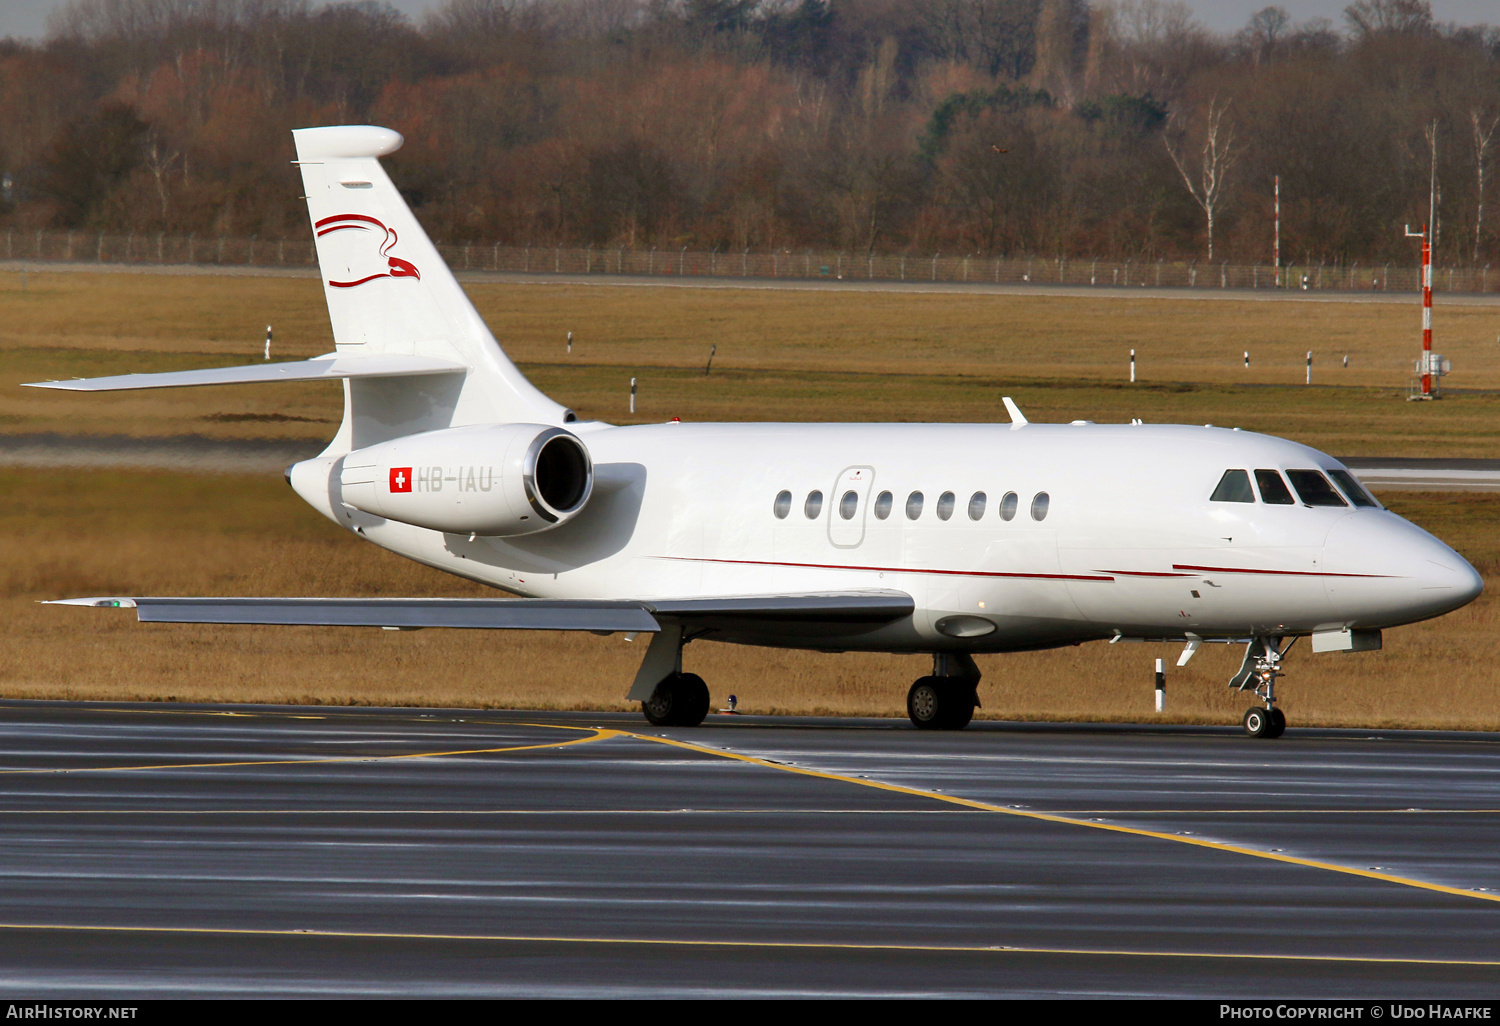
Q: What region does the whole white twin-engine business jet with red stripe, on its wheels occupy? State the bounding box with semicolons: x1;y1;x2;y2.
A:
29;126;1482;737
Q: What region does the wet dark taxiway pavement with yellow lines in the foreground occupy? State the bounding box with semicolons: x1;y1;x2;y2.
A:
0;702;1500;999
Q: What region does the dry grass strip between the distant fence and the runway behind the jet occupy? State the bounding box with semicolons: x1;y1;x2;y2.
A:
0;273;1500;456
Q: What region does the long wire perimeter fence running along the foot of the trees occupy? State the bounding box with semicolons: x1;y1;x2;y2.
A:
3;231;1500;293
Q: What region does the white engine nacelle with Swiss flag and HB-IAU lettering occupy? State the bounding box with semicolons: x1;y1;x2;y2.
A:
342;425;594;537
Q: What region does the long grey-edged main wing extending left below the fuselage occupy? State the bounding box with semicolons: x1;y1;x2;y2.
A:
48;591;915;632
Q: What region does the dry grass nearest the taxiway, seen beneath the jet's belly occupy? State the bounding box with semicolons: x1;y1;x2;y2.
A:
0;471;1500;729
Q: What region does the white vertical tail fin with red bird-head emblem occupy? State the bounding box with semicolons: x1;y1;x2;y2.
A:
293;125;573;449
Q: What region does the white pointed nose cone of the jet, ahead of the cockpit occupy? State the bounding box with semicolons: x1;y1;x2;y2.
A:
1323;510;1485;627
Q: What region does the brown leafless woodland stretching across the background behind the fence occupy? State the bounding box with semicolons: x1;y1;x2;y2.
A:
0;0;1500;266
